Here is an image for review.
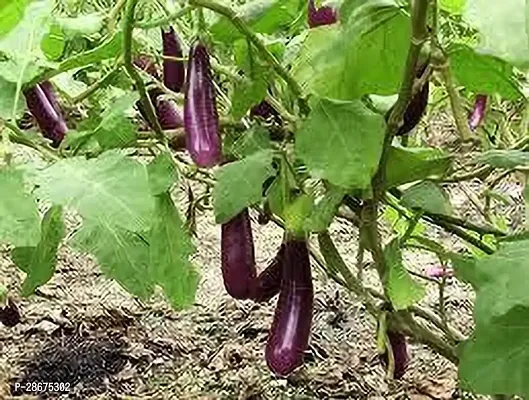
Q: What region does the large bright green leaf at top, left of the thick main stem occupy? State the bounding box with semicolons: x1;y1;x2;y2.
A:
293;0;410;99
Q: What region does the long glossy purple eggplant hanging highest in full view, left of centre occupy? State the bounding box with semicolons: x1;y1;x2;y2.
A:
184;41;222;168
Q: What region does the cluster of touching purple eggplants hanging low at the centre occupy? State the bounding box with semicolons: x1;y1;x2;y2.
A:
221;209;314;376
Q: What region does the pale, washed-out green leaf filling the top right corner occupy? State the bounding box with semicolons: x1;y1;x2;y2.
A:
463;0;529;68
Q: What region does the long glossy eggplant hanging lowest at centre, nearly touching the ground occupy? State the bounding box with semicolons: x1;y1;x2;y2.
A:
265;240;314;376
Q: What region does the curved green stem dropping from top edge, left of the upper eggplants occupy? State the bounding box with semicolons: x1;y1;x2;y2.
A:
123;0;167;144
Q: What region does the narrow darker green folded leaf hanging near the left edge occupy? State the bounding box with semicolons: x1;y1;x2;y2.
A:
11;206;65;296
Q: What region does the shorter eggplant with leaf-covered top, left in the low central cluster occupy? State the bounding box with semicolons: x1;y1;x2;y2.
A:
221;209;257;299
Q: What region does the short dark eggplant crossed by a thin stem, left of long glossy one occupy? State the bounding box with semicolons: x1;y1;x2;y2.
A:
162;26;185;92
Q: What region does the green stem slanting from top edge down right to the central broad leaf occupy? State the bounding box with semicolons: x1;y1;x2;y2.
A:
189;0;303;98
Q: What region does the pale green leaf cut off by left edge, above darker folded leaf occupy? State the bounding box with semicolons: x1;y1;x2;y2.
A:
0;168;40;246
